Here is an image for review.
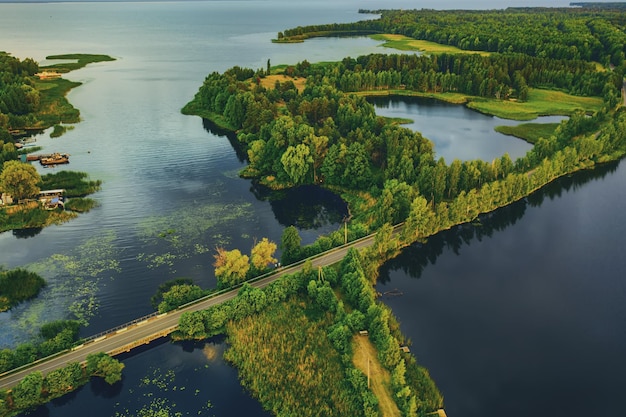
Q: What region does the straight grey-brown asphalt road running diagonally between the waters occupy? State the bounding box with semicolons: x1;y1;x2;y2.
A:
0;228;390;389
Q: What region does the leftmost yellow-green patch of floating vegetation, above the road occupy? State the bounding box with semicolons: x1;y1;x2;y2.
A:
0;232;120;347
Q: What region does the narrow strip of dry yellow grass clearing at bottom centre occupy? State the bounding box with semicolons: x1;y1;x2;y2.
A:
352;335;400;417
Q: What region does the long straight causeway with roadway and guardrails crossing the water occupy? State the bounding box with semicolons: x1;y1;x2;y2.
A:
0;225;394;390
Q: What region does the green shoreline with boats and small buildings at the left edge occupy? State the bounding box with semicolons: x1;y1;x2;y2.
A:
0;52;114;232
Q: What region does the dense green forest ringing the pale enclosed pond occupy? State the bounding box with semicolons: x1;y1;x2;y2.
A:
185;54;625;221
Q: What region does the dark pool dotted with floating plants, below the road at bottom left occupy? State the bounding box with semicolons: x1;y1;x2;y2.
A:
21;336;269;417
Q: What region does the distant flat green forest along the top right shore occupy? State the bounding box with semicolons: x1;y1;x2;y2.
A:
278;8;626;66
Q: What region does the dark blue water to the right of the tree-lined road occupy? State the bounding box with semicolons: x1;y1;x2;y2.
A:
377;162;626;417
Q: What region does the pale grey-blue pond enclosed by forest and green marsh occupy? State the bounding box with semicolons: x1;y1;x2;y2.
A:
367;96;564;164
